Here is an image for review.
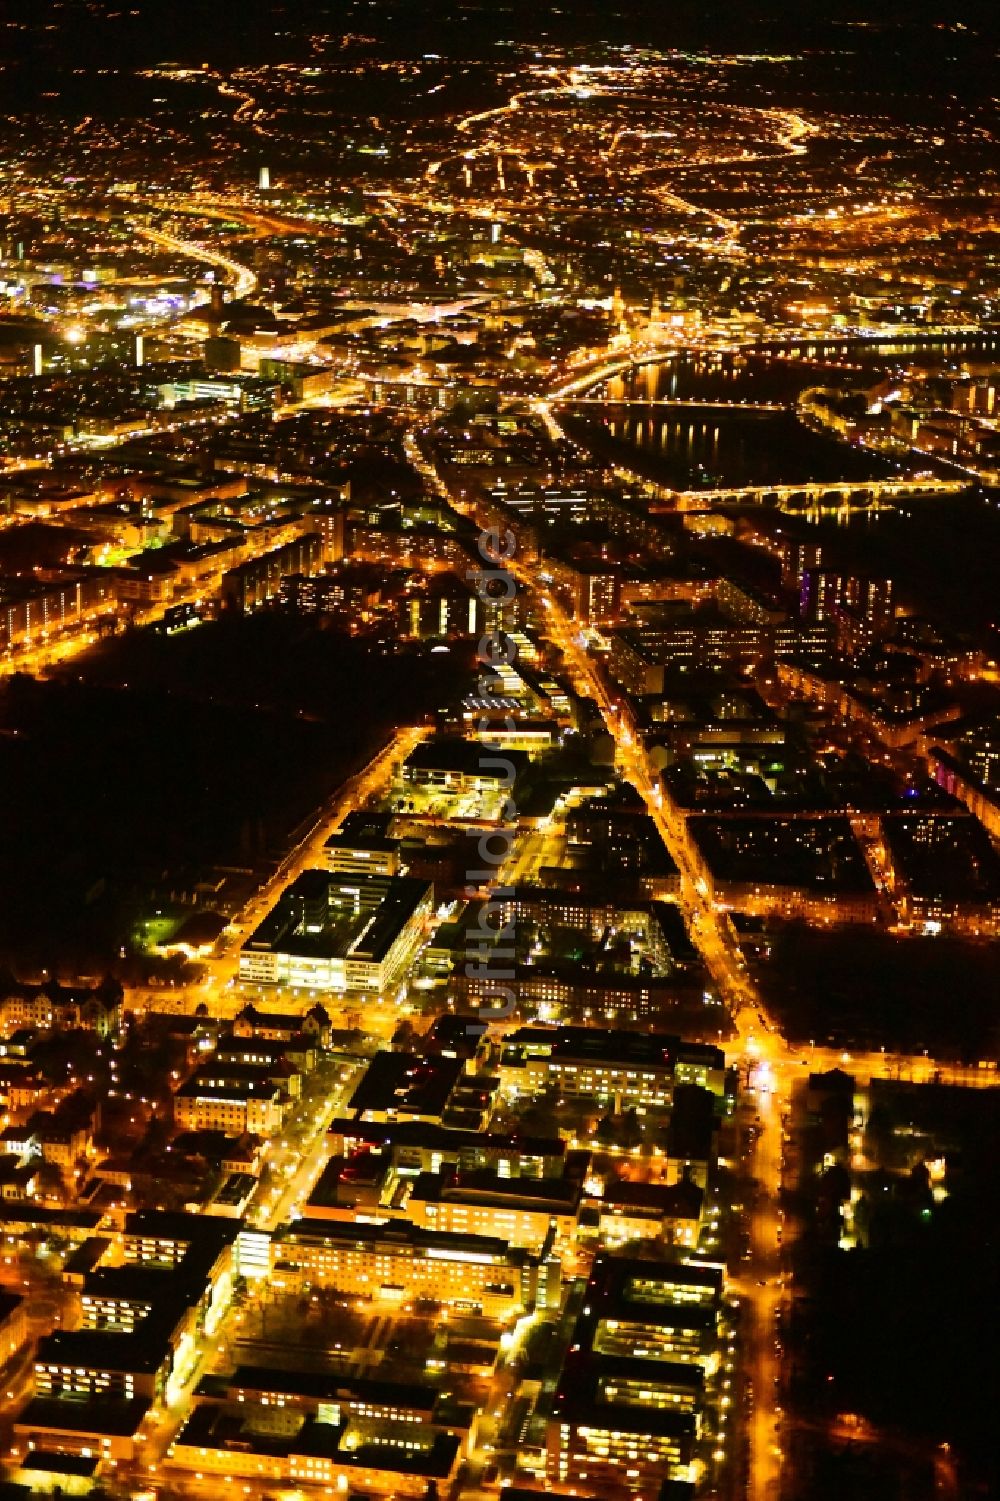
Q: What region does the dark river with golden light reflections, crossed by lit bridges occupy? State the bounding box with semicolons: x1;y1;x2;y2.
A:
569;335;1000;648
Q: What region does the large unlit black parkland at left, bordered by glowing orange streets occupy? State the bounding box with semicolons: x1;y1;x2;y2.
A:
0;615;462;976
